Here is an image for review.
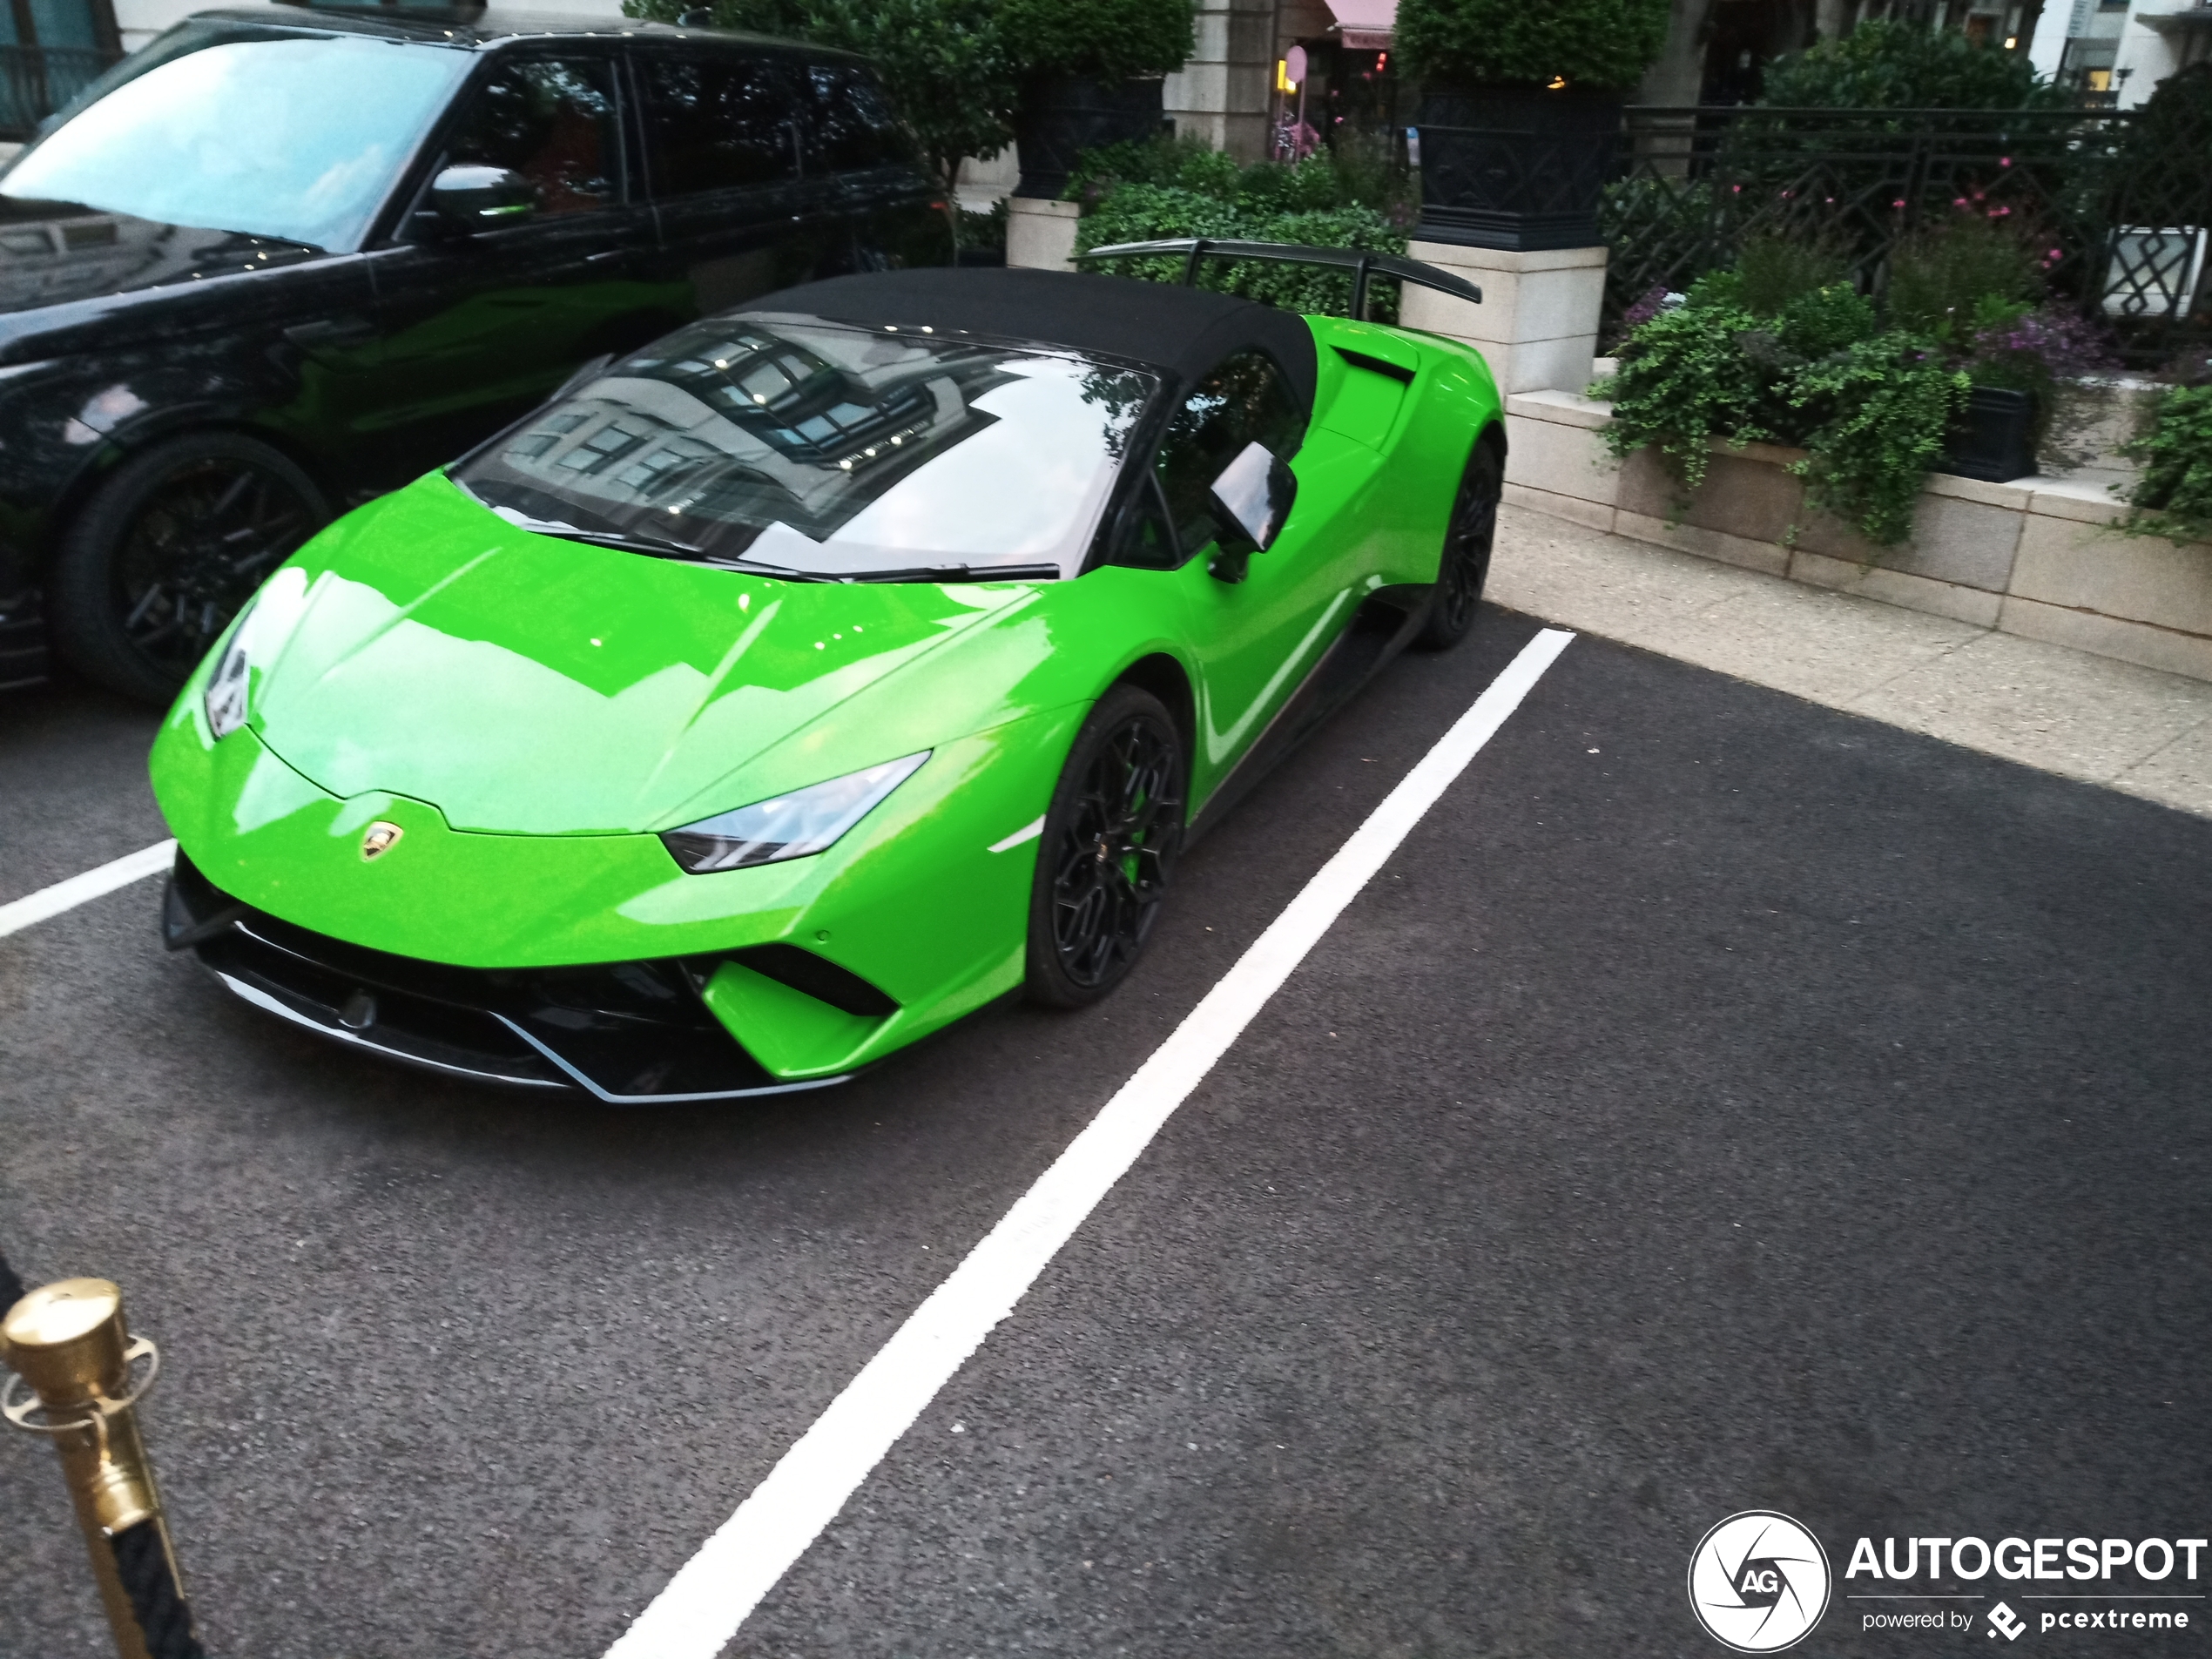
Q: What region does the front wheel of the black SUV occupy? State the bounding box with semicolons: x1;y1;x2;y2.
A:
49;431;329;701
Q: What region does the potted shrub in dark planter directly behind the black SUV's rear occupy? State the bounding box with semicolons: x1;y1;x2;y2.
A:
998;0;1192;199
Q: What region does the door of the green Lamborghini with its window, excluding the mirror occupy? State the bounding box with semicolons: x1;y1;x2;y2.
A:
1137;345;1373;792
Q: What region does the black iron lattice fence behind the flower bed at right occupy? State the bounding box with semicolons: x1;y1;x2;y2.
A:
1602;106;2212;368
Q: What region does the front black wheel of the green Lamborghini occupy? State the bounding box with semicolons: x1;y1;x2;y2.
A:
1028;685;1185;1008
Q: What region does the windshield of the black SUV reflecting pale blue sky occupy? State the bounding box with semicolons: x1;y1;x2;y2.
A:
0;37;469;250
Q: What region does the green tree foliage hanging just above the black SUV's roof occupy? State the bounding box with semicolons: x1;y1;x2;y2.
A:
622;0;1015;201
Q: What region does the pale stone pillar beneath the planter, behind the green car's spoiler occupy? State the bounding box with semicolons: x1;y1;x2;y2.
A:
1398;241;1606;394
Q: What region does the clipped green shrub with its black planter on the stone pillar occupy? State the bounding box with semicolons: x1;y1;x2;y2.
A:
1398;0;1670;253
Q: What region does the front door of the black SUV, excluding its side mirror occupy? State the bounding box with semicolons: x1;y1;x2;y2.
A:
361;42;684;478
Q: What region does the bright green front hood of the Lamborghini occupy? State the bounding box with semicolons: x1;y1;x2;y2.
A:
253;474;1033;834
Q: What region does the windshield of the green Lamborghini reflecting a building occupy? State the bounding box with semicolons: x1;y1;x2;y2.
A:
454;314;1159;577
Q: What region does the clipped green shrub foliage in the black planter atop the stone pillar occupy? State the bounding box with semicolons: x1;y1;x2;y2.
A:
1398;0;1670;91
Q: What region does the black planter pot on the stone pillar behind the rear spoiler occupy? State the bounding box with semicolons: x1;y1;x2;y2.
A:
1413;86;1622;253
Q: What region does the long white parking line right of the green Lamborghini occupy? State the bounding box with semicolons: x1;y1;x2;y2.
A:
606;628;1575;1659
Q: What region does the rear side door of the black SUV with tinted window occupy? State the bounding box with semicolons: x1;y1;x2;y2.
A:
631;42;847;316
